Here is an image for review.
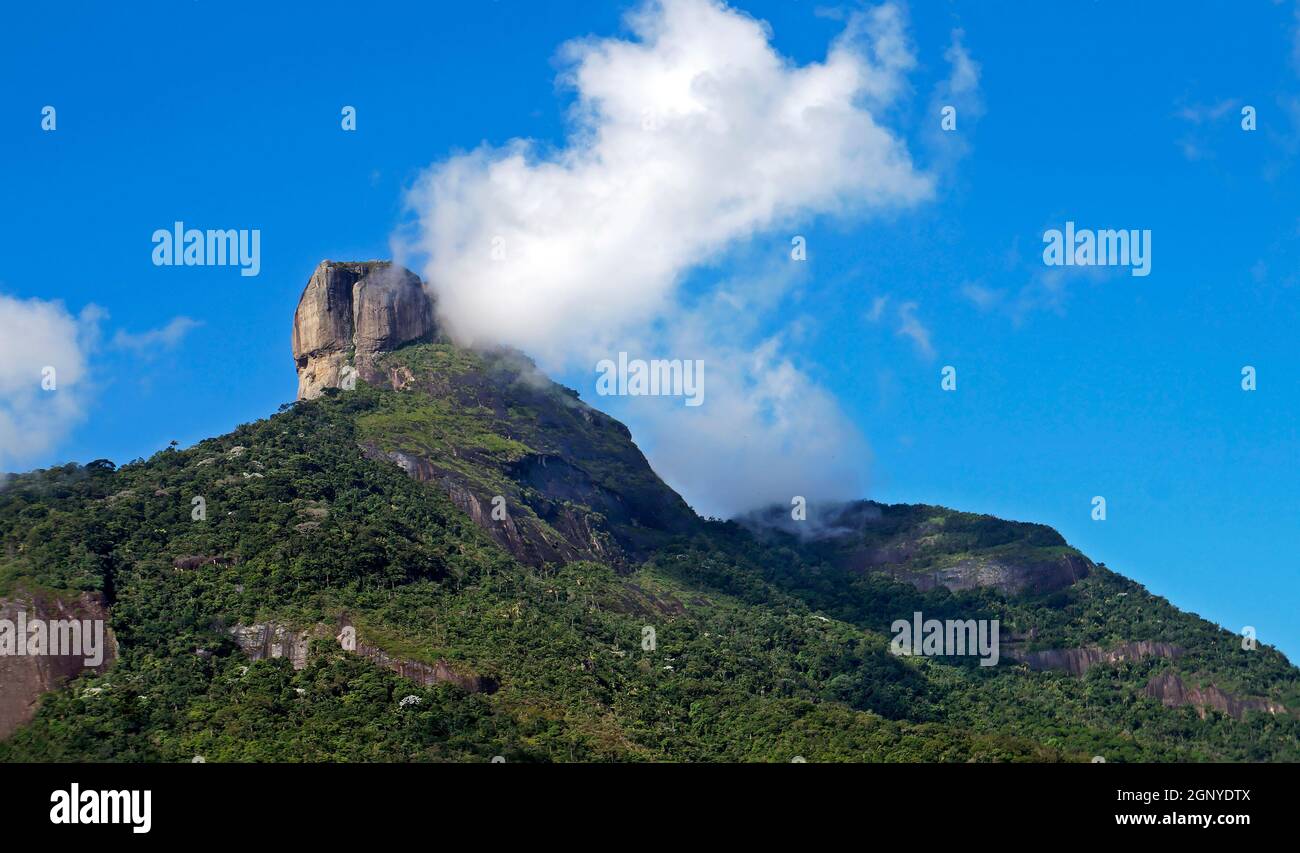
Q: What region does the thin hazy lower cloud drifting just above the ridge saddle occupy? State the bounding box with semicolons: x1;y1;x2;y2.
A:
624;265;871;516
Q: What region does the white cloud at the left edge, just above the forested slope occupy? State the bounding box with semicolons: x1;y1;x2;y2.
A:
0;294;103;469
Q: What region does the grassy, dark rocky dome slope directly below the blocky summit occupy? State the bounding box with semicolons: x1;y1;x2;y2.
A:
358;343;698;567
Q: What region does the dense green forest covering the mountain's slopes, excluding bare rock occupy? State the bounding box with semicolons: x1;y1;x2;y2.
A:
0;358;1300;762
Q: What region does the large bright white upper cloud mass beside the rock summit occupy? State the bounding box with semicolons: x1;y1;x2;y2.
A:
408;0;931;360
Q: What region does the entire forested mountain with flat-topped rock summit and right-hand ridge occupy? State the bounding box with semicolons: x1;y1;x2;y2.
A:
0;261;1300;762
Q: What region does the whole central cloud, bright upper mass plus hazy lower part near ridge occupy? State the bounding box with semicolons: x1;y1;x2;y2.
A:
395;0;933;511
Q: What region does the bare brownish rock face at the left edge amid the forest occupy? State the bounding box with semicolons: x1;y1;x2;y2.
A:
0;593;117;739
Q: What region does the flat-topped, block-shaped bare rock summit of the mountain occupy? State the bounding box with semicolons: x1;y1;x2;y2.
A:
294;260;437;399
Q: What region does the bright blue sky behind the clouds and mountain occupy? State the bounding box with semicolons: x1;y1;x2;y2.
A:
0;0;1300;659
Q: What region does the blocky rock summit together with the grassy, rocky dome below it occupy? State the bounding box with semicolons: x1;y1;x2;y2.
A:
294;261;697;568
